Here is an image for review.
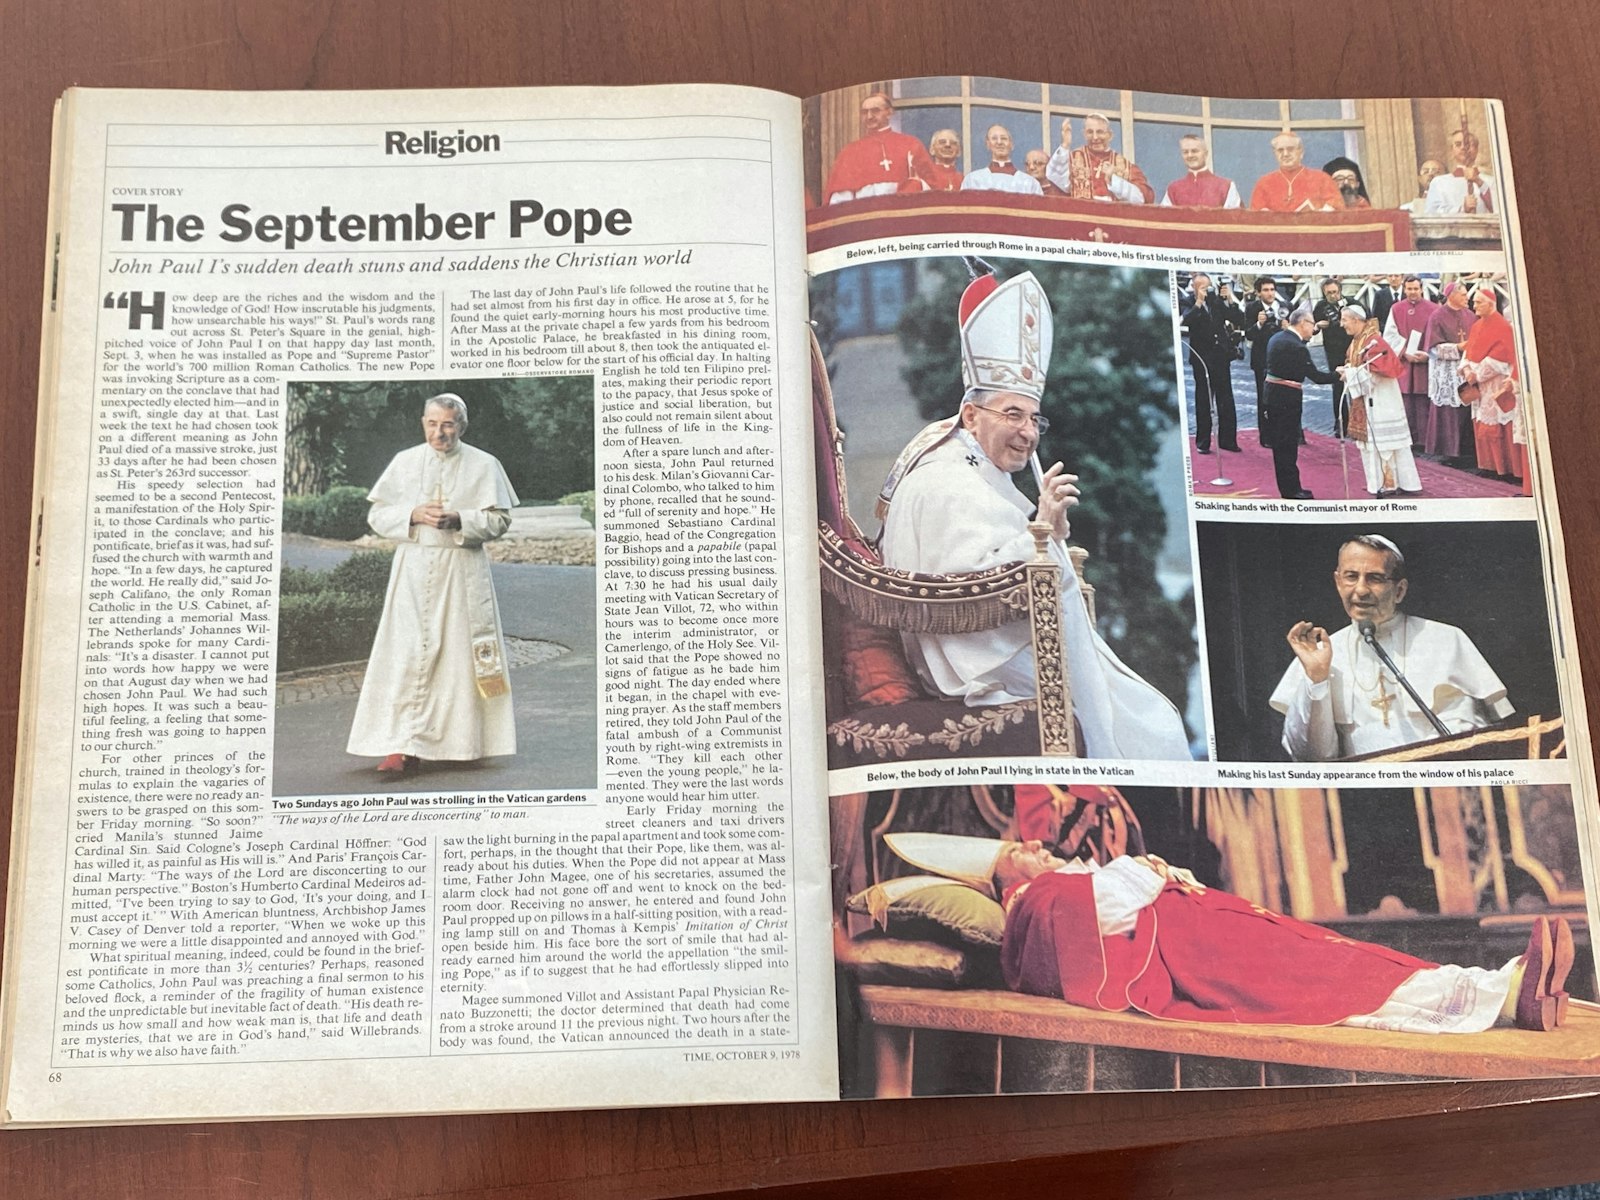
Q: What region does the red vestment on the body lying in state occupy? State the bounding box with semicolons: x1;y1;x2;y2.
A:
1000;874;1434;1026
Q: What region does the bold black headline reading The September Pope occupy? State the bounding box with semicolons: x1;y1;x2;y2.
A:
110;200;634;250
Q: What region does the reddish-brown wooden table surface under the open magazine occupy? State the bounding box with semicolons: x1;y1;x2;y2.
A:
0;0;1600;1200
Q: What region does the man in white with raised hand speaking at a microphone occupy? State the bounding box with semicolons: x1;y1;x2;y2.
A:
1272;533;1512;762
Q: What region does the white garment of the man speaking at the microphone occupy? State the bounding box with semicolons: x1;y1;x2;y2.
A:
1272;613;1514;762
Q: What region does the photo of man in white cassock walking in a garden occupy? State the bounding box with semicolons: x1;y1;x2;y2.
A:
274;376;597;795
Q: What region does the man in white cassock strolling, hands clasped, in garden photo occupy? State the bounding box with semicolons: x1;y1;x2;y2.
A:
346;392;517;776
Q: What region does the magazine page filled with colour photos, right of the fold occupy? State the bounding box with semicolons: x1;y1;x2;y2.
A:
805;77;1600;1096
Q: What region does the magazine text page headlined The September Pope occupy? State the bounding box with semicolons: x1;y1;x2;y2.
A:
5;88;837;1123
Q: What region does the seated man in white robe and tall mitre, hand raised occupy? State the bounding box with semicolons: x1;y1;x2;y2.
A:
878;274;1190;760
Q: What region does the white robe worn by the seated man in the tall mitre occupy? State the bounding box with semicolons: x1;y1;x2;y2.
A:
882;429;1192;760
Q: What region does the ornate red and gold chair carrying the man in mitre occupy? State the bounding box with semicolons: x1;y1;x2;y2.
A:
811;338;1094;768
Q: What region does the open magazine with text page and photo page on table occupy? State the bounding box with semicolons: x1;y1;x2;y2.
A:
3;77;1600;1125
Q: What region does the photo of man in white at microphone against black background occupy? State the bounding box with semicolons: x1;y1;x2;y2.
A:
1197;522;1565;762
